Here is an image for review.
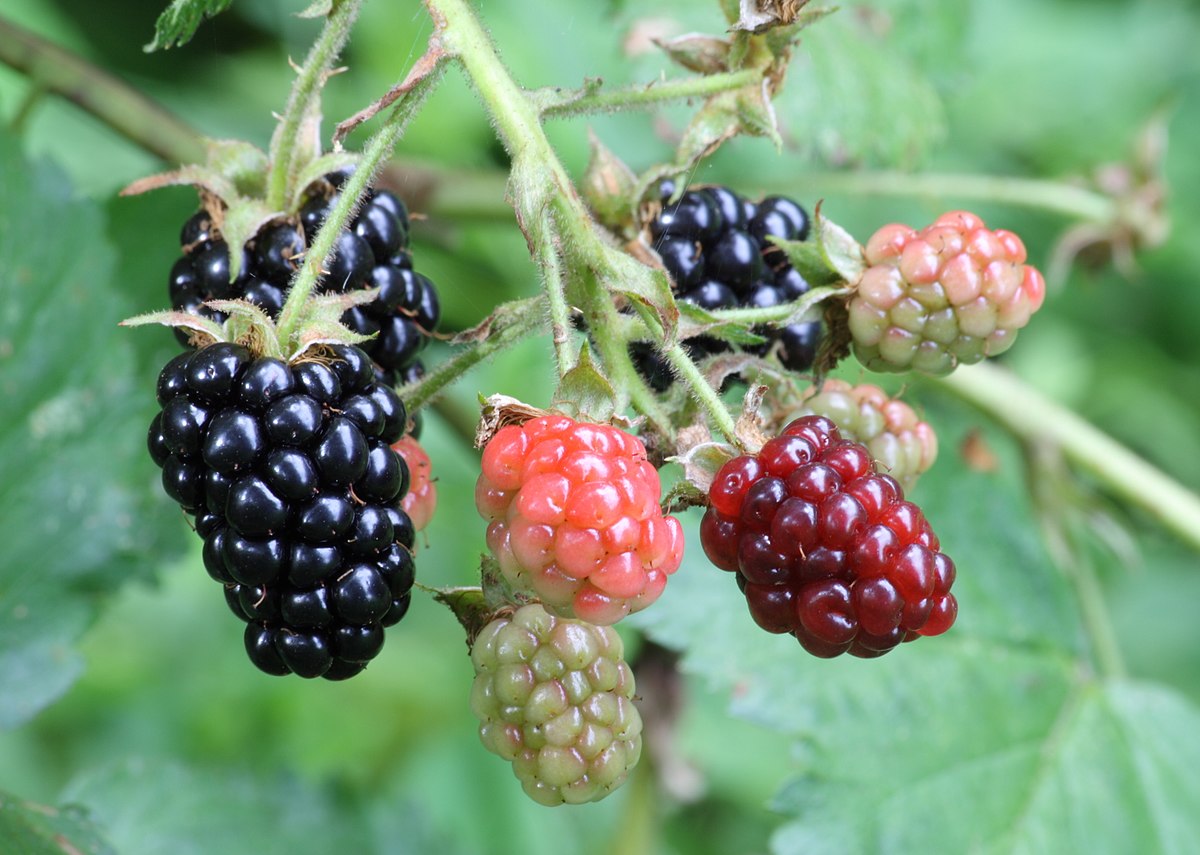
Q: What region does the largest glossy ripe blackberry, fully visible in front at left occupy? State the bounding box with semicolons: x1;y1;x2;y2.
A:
148;342;414;680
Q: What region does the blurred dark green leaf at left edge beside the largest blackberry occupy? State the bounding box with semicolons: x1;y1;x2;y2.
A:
0;140;184;728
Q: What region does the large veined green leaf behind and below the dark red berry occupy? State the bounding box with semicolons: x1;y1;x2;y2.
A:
630;399;1200;855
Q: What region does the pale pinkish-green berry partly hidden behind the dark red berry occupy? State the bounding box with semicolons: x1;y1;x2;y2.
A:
793;379;937;491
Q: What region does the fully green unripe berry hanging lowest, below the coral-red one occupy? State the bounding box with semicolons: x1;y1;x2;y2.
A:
470;603;642;807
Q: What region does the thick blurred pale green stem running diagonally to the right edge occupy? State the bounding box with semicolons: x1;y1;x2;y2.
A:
934;364;1200;549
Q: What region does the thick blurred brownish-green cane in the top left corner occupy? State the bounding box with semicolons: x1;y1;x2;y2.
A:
0;18;205;163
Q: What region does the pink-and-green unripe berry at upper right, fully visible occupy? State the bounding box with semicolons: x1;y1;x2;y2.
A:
848;211;1045;375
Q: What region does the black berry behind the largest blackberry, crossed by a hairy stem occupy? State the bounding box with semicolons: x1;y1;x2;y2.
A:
163;173;440;385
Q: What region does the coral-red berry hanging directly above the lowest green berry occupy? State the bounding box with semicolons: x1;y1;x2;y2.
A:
475;415;684;624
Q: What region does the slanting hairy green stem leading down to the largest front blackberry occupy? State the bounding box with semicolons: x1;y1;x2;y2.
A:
278;53;442;349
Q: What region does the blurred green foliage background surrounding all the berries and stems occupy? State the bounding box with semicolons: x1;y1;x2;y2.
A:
0;0;1200;855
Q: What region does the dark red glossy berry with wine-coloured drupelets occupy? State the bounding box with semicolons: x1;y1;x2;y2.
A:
700;415;958;658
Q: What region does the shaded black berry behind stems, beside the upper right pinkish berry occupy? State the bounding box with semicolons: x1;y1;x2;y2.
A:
632;181;821;391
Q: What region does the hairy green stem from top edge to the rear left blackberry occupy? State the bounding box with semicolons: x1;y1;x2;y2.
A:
266;0;362;210
